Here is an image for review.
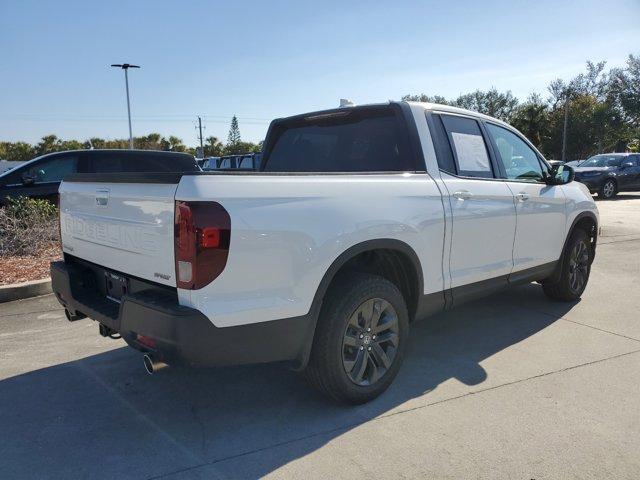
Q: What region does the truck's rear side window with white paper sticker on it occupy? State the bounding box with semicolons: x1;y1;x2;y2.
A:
441;115;494;178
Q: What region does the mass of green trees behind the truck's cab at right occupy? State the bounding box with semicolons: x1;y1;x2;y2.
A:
402;55;640;159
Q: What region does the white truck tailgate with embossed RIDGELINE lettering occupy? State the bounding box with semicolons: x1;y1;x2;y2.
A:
60;181;177;286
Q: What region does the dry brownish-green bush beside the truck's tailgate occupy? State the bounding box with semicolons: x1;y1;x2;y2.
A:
0;197;58;256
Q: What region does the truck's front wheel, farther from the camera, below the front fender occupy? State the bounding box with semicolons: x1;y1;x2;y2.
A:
542;229;593;302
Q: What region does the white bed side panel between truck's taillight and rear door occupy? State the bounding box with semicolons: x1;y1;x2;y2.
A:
176;174;444;327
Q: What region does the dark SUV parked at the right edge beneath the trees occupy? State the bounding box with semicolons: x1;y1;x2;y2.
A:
574;153;640;199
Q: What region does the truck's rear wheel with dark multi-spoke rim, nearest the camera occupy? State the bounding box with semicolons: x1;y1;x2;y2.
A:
303;273;409;404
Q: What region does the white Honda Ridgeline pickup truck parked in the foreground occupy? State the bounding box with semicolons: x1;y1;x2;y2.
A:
51;102;598;403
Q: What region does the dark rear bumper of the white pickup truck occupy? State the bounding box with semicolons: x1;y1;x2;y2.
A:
51;261;314;366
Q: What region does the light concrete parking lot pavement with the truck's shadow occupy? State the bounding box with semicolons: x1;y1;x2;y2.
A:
0;194;640;479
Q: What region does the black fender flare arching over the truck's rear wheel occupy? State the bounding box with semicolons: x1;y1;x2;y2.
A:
294;238;424;370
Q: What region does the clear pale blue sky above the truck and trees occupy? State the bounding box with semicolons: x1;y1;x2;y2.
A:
0;0;640;145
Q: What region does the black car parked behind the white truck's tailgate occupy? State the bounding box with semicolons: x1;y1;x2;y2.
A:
0;150;200;205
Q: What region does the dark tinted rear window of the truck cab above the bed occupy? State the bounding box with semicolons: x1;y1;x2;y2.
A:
262;107;415;172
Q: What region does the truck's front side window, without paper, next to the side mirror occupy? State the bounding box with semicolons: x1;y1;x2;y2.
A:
486;123;544;182
